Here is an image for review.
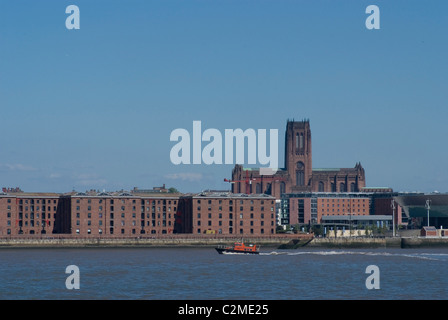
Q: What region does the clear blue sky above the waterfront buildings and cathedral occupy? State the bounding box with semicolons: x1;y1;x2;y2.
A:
0;0;448;192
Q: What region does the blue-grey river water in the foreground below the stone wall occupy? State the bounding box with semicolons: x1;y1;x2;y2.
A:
0;248;448;300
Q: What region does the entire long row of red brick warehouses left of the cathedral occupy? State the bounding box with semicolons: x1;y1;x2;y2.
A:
0;191;276;237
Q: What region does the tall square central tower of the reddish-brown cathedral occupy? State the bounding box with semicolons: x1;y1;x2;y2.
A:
285;120;313;192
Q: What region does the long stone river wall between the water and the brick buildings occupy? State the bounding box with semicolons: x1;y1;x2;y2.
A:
0;234;448;249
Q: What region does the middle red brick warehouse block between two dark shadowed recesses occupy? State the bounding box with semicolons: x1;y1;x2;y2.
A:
58;192;179;236
